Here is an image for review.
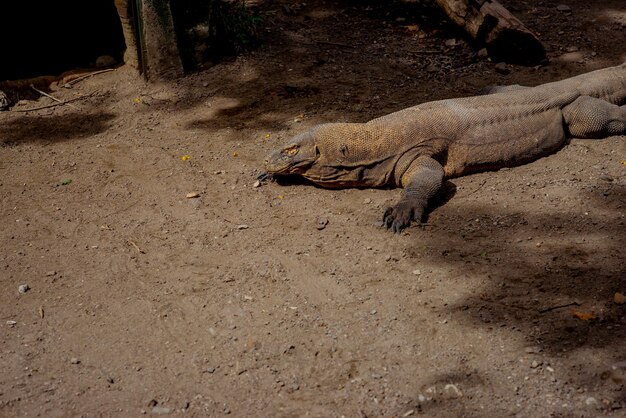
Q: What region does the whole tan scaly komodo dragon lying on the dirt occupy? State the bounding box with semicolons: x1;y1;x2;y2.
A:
266;63;626;232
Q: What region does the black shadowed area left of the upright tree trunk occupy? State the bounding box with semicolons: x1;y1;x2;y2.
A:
0;0;125;80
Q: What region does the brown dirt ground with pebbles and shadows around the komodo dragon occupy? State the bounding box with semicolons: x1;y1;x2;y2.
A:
0;0;626;417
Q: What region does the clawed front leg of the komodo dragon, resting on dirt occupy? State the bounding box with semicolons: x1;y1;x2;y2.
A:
383;156;444;233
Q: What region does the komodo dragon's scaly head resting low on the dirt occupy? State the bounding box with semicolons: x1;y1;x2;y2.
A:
265;123;364;187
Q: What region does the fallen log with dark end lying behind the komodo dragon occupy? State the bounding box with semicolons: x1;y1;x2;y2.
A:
435;0;546;65
